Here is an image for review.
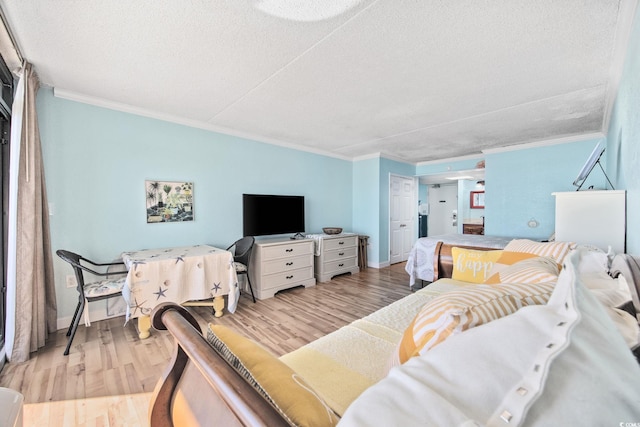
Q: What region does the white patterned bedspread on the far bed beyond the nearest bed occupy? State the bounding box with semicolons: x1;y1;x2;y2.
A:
405;234;513;287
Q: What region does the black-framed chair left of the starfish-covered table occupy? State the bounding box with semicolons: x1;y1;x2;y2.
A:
56;249;127;356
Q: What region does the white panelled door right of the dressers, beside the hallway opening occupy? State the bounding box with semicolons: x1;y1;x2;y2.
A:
389;176;417;264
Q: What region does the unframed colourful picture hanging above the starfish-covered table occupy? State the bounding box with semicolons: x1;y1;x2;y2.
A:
144;181;193;223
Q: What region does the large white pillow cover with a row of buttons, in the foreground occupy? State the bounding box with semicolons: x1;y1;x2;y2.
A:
340;252;640;426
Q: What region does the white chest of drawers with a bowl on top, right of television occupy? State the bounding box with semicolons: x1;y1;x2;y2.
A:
307;233;360;282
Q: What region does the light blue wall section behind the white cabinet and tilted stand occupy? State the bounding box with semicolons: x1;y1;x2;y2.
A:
485;139;606;239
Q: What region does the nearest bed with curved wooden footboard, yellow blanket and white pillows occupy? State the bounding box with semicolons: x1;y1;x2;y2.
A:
149;242;640;426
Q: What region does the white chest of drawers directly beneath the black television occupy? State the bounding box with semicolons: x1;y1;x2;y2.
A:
249;238;316;299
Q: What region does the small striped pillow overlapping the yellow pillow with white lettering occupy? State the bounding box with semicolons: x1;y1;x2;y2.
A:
485;255;560;284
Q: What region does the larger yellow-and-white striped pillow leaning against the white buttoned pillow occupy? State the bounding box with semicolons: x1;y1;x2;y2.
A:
392;283;555;365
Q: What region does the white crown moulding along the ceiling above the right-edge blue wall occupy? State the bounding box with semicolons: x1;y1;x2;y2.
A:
602;0;638;134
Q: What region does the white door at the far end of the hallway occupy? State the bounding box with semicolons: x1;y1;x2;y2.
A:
427;184;458;236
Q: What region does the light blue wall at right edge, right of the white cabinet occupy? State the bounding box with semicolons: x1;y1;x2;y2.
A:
607;3;640;255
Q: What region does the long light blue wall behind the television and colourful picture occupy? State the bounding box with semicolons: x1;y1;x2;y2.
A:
38;88;352;317
